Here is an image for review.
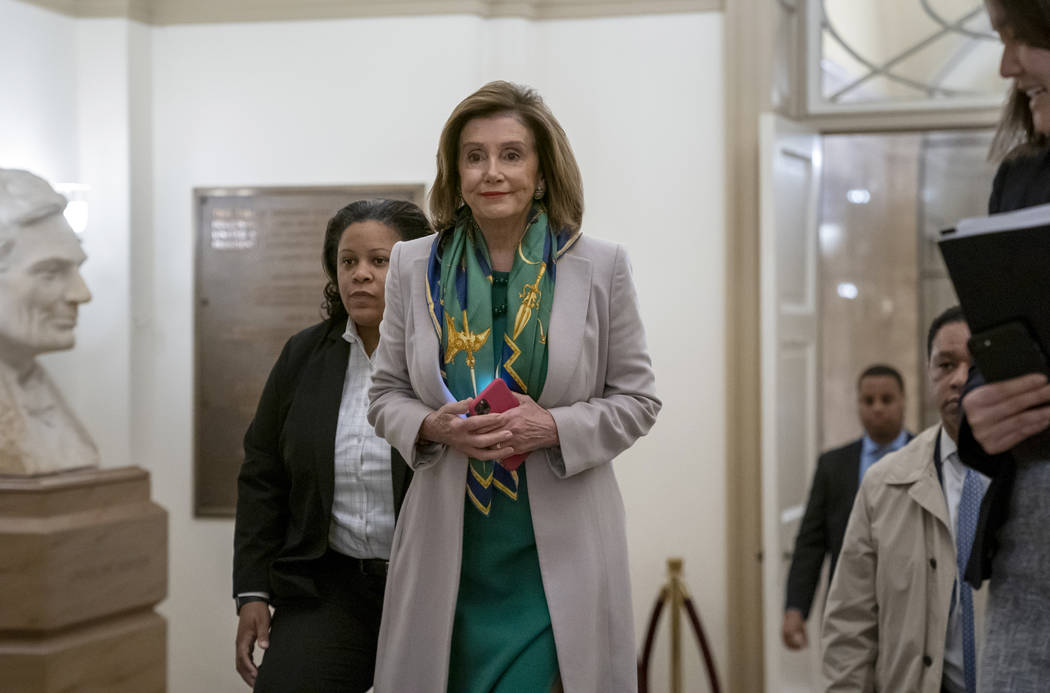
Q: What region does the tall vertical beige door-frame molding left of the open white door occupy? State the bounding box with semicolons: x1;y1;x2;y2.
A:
722;0;779;693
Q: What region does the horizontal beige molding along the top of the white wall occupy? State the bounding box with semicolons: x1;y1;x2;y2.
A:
16;0;726;25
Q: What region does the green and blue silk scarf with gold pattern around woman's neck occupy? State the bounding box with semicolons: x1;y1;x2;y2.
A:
427;204;579;516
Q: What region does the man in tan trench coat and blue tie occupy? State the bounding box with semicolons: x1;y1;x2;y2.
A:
823;308;988;693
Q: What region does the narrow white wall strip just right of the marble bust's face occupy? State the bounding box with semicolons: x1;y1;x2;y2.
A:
61;19;135;466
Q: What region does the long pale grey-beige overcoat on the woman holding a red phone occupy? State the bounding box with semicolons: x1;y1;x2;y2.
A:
369;236;660;693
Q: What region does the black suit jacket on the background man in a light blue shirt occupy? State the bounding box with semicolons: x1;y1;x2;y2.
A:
785;438;861;618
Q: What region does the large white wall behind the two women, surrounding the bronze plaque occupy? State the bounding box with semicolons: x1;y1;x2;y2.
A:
0;0;727;693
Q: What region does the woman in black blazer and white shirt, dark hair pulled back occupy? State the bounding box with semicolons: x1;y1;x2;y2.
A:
233;200;431;693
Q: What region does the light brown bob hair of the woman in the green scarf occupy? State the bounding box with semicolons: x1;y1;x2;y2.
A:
429;81;584;232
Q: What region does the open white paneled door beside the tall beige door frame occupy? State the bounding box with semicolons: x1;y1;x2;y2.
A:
760;113;821;693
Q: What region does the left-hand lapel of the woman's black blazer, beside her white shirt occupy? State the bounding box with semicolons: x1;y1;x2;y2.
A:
300;329;350;517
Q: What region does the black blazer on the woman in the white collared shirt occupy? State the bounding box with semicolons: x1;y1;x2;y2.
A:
233;321;412;604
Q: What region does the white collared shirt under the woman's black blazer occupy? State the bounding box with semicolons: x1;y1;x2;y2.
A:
329;320;394;559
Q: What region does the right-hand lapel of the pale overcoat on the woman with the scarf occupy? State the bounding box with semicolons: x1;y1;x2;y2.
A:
539;249;592;408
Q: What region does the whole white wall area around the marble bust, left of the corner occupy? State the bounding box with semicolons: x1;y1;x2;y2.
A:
0;0;131;466
